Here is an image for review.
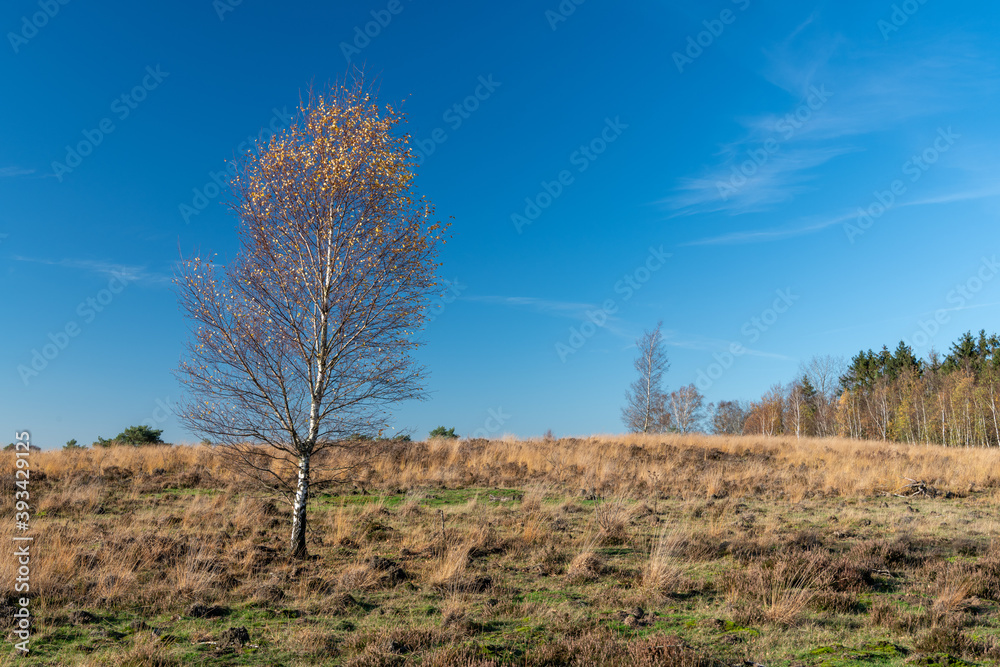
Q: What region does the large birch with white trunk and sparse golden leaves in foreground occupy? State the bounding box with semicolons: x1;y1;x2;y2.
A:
176;78;444;558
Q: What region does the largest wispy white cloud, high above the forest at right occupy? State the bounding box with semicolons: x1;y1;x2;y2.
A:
657;24;1000;219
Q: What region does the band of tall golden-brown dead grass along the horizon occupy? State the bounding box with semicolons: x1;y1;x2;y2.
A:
11;435;1000;510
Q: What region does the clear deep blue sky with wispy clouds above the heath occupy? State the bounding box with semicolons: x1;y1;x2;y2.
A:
0;0;1000;447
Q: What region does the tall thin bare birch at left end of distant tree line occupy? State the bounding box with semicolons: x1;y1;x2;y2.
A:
622;322;670;433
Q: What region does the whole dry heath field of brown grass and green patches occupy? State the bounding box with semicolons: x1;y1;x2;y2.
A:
0;436;1000;667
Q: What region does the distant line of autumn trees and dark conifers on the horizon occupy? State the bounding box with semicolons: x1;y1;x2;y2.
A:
622;323;1000;447
